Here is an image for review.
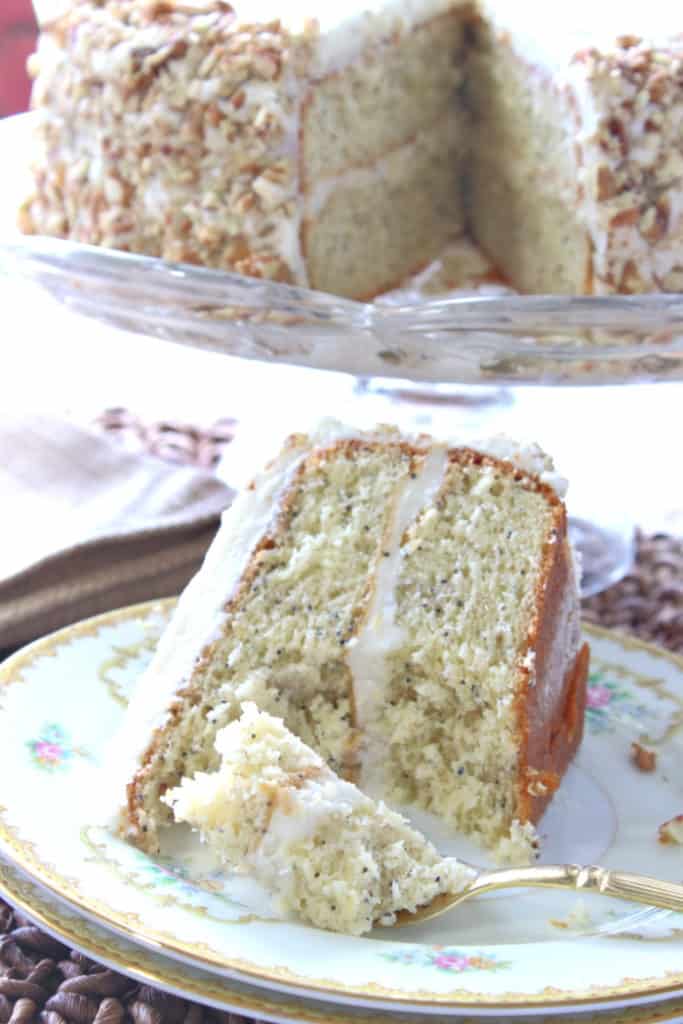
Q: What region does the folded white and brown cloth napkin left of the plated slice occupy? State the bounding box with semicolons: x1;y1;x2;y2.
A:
0;415;232;649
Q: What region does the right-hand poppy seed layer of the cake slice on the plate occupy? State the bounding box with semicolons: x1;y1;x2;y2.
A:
368;450;579;847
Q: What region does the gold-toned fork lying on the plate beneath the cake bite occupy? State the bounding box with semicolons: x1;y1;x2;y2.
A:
394;861;683;928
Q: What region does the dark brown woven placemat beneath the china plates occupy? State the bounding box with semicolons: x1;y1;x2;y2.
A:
0;409;683;1024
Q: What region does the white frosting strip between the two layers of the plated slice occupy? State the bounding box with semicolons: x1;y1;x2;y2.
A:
347;445;447;793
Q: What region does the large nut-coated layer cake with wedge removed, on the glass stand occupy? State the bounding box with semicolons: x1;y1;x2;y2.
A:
22;0;683;298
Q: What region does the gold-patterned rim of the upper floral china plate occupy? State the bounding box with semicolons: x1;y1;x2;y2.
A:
0;598;683;1012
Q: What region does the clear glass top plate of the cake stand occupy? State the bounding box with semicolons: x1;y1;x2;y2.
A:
0;112;683;386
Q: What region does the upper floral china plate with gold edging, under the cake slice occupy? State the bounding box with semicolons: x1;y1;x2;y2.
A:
0;602;683;1017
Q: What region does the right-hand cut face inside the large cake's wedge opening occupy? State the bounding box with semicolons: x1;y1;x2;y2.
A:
466;22;593;295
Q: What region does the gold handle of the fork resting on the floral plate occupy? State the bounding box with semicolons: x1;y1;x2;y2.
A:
471;864;683;911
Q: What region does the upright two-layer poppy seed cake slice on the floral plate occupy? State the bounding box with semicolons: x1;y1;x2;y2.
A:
114;424;587;864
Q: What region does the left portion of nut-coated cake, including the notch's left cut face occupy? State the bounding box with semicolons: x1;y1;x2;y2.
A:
23;0;467;297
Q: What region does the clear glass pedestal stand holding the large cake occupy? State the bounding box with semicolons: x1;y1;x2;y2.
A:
0;116;683;594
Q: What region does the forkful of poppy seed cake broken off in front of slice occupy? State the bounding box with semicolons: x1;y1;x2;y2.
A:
164;702;471;935
